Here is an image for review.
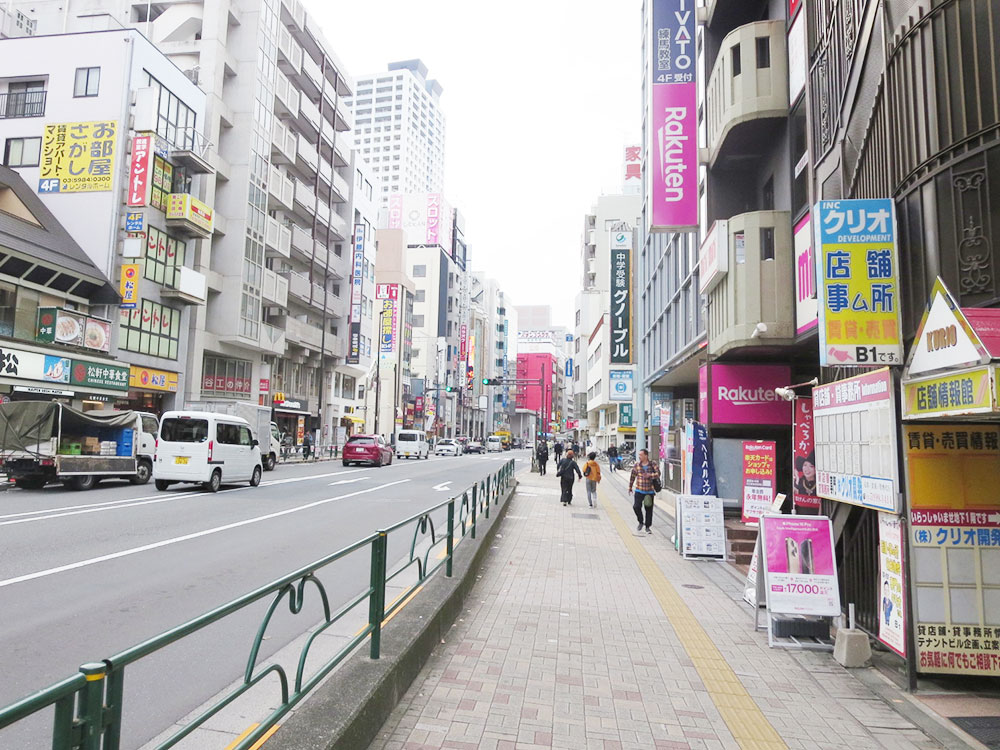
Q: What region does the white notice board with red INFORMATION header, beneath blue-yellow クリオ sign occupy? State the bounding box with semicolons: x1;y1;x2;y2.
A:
813;367;900;513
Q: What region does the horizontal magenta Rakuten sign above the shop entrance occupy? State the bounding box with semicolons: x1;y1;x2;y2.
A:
702;365;792;425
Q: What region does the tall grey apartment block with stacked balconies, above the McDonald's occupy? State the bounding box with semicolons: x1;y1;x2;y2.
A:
19;0;374;444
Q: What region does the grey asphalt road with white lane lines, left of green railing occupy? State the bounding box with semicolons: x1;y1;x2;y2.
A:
0;451;529;750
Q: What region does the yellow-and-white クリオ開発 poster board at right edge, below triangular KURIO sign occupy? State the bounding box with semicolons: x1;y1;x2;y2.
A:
903;423;1000;676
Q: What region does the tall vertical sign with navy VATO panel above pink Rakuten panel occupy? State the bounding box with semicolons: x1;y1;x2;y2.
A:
647;0;698;231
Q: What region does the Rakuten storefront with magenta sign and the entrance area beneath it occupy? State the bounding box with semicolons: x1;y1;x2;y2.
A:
698;364;794;507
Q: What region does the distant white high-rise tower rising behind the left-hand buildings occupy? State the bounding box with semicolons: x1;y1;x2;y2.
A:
347;60;445;208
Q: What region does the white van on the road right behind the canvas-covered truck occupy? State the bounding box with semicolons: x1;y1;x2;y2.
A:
153;411;263;492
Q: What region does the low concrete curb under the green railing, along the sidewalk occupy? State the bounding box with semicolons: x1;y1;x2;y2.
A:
267;477;517;750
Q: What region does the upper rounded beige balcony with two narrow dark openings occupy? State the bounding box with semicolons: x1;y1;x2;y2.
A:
705;20;788;166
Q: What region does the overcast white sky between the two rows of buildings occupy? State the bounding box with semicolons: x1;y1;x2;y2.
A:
314;0;641;327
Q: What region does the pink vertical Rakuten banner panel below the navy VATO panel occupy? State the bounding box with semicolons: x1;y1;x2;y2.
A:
649;83;698;229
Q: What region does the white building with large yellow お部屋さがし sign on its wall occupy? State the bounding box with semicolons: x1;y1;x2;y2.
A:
0;29;208;411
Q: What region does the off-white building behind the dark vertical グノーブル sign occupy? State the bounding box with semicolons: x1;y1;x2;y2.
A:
573;195;642;450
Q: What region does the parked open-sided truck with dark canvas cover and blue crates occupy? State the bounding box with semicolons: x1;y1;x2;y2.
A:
0;401;159;490
